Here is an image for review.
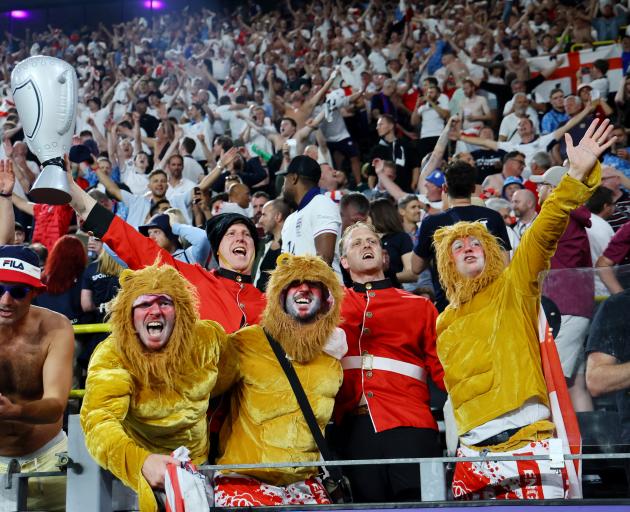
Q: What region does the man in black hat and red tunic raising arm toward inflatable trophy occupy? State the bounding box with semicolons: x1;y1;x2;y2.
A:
70;164;265;333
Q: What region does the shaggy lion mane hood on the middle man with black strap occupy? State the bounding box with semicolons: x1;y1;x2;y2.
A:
260;254;343;363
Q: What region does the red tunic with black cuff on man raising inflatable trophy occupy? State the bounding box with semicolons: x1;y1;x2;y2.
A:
83;205;265;333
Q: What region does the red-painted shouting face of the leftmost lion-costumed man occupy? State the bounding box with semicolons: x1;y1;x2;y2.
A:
132;294;175;350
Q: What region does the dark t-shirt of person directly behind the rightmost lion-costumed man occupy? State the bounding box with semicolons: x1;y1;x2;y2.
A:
413;205;512;312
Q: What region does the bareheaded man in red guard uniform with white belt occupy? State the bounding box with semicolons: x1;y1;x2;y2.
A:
333;222;444;502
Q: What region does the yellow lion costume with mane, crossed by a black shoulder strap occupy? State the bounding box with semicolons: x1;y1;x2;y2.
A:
217;254;347;485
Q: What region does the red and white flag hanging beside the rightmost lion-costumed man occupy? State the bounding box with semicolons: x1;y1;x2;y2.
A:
538;306;582;499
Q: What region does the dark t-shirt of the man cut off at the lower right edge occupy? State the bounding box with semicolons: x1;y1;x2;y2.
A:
586;289;630;444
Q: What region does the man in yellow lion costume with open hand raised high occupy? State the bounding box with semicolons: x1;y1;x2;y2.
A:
435;117;612;499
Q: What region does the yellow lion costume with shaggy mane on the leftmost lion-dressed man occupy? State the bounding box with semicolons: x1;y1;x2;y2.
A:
81;264;226;512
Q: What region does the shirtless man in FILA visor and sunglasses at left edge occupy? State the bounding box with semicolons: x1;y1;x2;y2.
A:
0;162;74;511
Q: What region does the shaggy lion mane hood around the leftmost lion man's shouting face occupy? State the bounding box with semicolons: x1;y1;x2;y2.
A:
109;262;199;391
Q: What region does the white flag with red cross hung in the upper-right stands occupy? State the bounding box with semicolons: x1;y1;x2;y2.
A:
527;44;623;101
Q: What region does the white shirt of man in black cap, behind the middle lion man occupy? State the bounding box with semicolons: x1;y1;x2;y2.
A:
282;194;342;281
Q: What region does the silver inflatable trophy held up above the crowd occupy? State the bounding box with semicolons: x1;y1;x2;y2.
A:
11;55;78;204
